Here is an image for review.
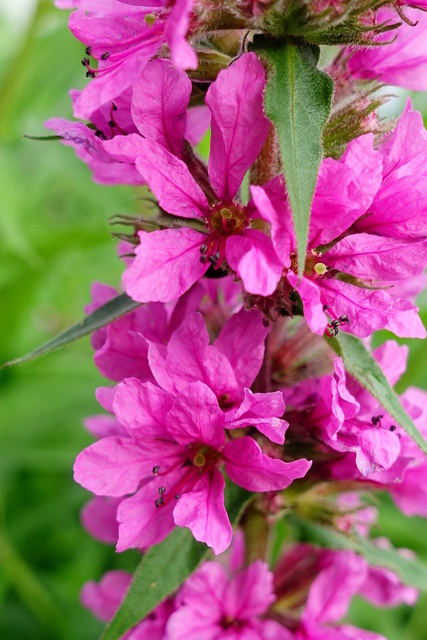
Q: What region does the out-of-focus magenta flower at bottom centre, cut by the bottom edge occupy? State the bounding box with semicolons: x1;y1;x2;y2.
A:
166;560;294;640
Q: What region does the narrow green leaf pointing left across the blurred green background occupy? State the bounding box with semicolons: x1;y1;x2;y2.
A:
2;293;141;368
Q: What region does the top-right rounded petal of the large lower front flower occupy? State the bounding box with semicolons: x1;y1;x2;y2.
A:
166;382;225;449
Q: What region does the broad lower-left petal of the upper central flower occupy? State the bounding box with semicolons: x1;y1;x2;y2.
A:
123;229;209;302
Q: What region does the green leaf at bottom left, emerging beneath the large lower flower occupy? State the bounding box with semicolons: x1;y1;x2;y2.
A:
101;485;253;640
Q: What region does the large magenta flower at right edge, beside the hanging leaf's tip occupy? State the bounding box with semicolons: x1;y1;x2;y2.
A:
258;119;427;338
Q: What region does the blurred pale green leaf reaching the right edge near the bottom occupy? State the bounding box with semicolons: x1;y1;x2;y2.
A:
287;514;427;590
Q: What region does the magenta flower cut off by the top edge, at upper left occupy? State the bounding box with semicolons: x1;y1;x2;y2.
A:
61;0;197;119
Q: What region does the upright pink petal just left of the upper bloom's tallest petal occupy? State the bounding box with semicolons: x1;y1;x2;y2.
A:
132;60;191;157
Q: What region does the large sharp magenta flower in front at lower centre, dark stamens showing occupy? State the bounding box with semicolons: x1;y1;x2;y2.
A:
75;378;311;553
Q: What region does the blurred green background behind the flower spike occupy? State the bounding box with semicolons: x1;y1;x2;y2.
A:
0;0;427;640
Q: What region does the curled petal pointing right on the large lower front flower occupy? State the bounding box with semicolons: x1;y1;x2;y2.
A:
223;437;311;491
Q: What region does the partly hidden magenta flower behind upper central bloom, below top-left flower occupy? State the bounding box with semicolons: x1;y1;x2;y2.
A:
45;60;210;185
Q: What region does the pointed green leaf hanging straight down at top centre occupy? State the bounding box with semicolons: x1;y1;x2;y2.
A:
251;36;334;277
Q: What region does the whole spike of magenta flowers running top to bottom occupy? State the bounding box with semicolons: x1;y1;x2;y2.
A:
46;0;427;640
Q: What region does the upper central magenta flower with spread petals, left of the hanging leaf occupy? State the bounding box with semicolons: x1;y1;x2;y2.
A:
103;53;290;302
